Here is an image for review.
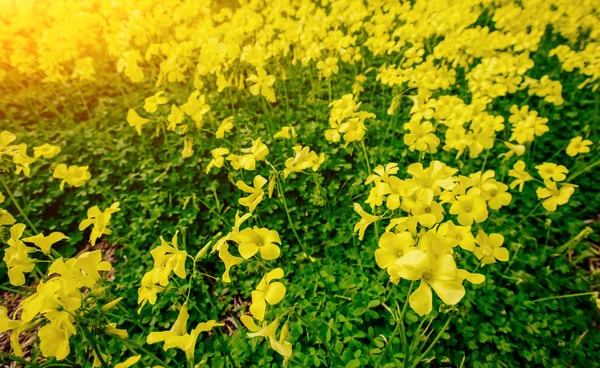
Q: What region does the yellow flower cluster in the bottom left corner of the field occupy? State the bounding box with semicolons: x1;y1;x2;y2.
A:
0;224;112;360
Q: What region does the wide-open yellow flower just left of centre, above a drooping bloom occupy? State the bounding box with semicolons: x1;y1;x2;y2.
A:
234;226;281;261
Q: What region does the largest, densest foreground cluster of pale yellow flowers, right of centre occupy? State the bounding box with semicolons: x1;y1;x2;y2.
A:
354;161;512;315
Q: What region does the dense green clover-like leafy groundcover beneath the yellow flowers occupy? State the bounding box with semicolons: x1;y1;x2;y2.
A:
0;2;600;367
